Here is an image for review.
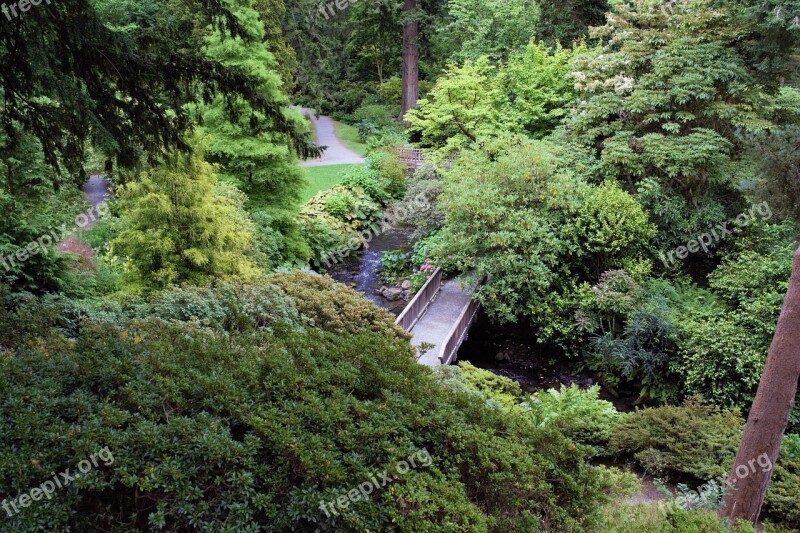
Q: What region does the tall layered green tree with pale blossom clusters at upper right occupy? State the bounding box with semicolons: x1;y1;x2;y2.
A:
571;0;792;209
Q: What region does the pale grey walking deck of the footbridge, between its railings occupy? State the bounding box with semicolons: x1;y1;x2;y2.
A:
411;278;474;366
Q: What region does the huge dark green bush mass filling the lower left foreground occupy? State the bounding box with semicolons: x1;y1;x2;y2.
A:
0;273;632;532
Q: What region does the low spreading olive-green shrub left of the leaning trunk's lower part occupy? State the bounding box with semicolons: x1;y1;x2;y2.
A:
609;397;744;481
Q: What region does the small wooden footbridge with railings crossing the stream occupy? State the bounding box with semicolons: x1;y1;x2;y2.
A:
395;268;480;366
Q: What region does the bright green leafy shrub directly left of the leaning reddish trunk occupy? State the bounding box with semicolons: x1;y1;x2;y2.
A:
676;220;795;409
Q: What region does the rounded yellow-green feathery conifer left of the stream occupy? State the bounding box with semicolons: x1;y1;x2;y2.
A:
111;143;255;291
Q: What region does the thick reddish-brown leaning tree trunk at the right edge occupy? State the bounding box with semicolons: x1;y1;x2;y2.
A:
720;250;800;523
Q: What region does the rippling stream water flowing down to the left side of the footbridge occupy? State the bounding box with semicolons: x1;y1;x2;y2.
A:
327;229;412;315
